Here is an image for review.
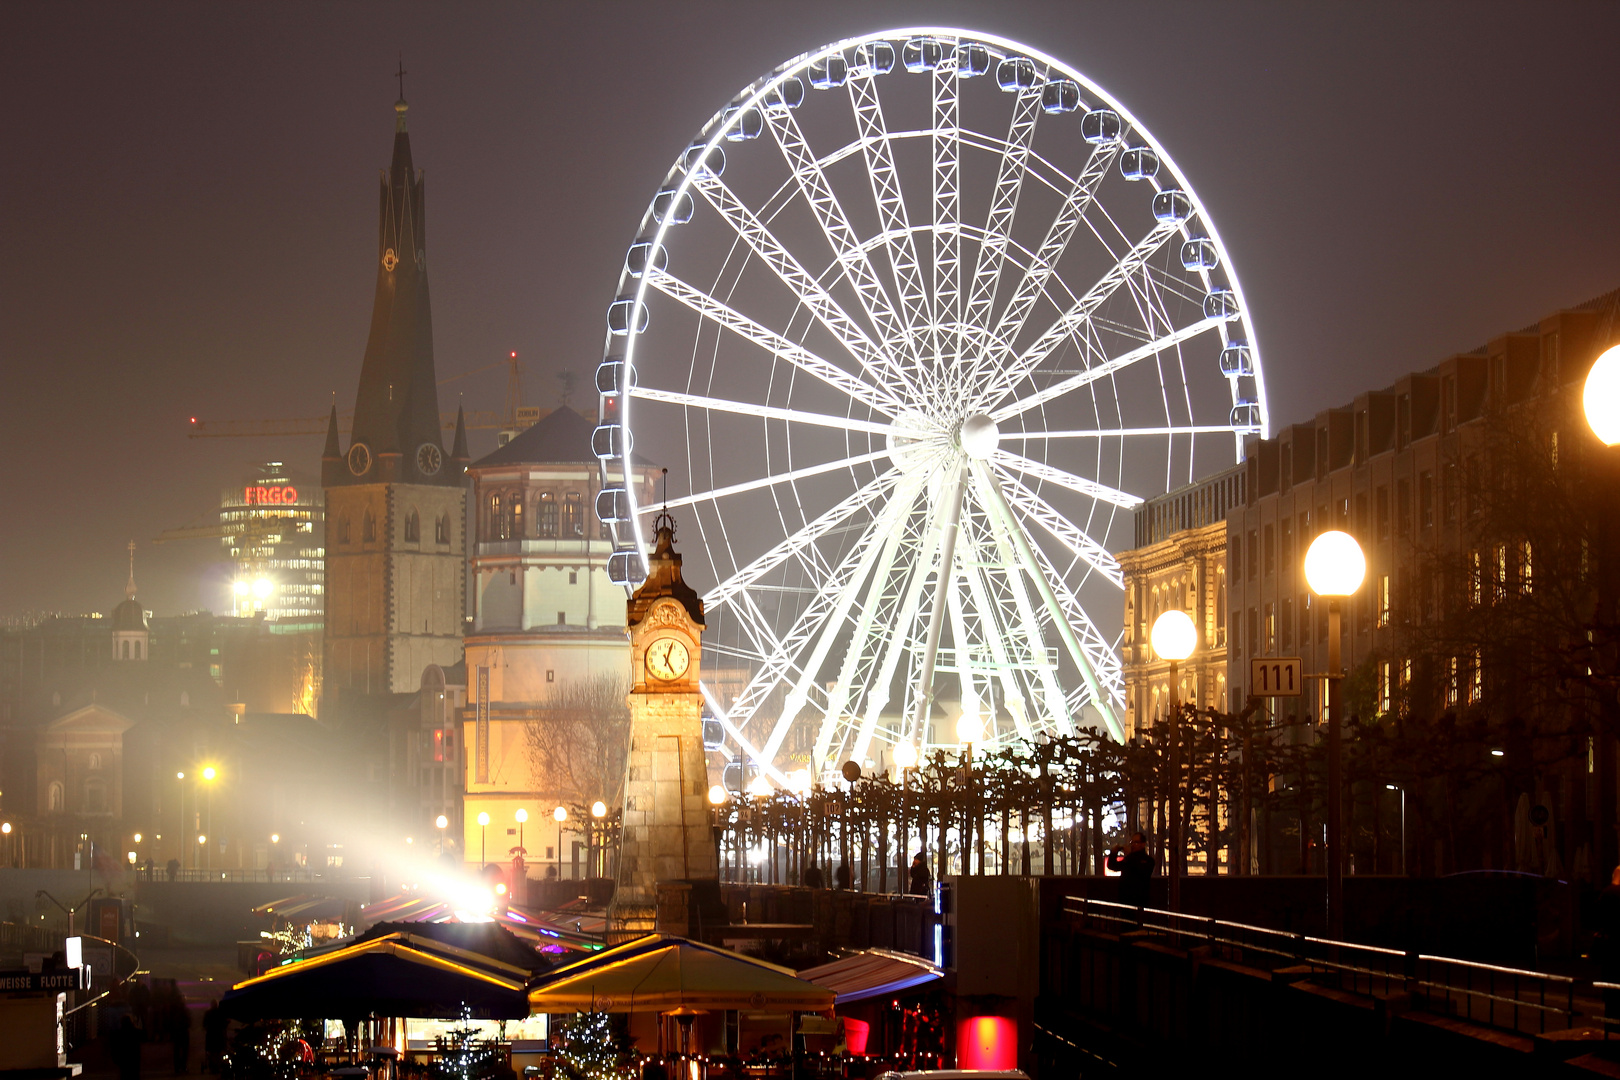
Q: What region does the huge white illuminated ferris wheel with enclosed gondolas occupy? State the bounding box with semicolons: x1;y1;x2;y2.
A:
595;29;1267;782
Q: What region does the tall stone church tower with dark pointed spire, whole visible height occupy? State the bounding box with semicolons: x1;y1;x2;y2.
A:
321;89;468;721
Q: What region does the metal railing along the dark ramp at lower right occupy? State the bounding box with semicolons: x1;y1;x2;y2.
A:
1063;897;1581;1033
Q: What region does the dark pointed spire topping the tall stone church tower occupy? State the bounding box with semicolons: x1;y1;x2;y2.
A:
327;89;458;486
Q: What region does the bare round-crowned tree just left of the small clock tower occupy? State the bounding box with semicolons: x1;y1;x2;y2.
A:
523;675;630;806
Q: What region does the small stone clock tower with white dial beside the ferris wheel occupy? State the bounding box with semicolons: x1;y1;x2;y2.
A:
608;513;719;939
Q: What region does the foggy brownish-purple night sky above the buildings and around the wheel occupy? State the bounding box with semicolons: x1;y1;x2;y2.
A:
0;0;1620;615
